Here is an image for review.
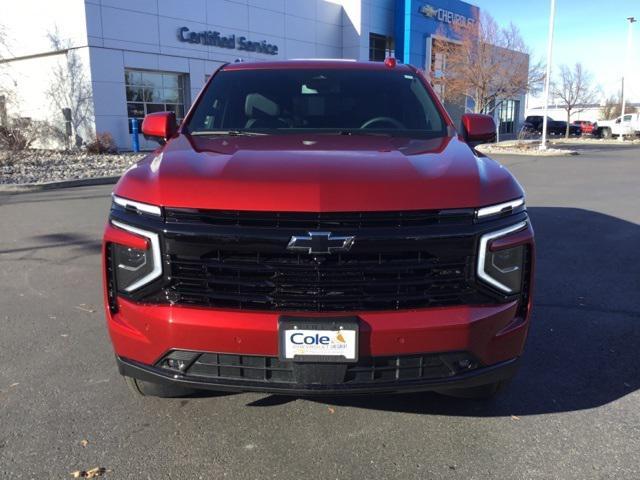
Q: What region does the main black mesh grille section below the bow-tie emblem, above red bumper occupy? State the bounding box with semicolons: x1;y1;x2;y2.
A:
166;237;486;311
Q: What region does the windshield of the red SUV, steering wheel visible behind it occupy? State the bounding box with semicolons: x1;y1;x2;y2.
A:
187;69;446;137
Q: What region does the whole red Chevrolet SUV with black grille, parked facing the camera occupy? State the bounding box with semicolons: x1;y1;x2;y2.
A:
103;60;534;397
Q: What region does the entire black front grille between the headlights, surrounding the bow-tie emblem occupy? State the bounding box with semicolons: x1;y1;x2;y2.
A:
146;209;495;312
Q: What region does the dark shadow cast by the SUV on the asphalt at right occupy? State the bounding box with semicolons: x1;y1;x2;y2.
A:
249;207;640;416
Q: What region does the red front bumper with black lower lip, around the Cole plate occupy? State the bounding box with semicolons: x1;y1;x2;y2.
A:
107;298;529;395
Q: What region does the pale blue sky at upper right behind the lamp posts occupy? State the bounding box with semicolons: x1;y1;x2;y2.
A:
470;0;640;106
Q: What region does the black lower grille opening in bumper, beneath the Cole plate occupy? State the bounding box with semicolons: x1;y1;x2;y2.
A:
165;352;480;385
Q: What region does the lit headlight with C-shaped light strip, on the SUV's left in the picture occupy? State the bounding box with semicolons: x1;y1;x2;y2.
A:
111;220;162;292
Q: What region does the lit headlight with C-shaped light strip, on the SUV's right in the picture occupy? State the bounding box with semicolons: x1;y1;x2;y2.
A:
478;222;527;294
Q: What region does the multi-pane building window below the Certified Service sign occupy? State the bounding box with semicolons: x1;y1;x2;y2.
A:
124;69;187;130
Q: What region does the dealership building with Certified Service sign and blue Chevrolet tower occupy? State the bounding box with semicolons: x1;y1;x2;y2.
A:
0;0;524;149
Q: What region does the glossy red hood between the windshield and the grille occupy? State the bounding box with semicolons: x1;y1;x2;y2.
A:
115;134;523;212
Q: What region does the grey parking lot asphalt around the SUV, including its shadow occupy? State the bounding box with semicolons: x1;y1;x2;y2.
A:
0;147;640;479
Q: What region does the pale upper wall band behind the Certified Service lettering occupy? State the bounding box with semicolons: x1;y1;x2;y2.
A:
86;0;350;61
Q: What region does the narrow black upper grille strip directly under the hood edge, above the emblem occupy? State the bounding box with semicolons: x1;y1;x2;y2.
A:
165;208;474;231
